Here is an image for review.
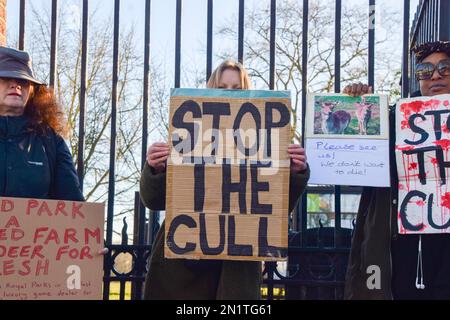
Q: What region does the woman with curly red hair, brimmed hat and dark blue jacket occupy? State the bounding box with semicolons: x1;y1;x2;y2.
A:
0;47;84;201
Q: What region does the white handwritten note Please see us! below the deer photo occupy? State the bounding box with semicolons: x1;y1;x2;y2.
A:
306;139;390;187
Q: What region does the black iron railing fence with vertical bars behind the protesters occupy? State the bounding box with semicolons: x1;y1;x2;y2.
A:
9;0;450;299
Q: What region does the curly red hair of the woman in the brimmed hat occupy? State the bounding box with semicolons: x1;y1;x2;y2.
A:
25;85;68;137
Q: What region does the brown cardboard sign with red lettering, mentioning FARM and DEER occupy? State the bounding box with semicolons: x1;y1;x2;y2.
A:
0;198;104;300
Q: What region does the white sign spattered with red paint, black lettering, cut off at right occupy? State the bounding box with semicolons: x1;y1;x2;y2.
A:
395;94;450;234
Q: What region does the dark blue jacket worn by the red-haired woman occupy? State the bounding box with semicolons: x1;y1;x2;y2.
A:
0;116;84;201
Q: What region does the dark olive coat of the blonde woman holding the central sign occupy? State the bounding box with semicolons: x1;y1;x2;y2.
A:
140;163;309;300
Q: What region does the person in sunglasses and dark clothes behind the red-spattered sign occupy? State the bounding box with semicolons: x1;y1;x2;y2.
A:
343;41;450;300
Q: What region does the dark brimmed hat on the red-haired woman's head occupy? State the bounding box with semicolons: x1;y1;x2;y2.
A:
0;46;45;85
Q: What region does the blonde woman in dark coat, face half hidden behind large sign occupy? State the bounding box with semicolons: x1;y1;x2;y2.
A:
140;60;309;300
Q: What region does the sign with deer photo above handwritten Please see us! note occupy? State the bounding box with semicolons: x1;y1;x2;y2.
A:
305;94;390;187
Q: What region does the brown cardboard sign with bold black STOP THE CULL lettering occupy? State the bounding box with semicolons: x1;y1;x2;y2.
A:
164;89;290;261
